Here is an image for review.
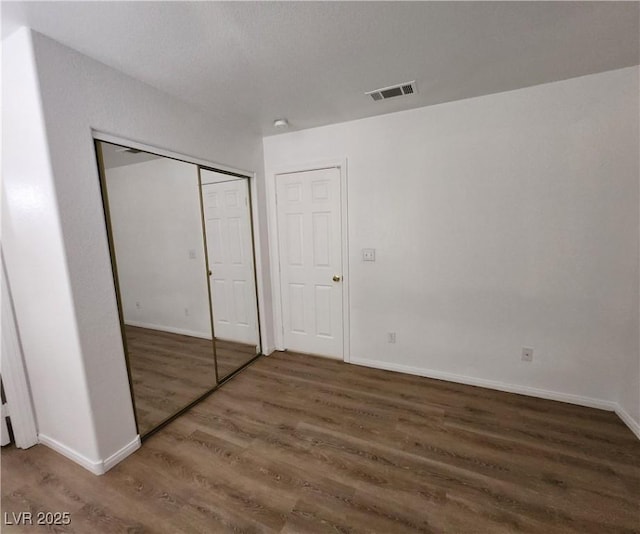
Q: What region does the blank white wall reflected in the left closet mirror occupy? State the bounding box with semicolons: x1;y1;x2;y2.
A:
107;158;211;338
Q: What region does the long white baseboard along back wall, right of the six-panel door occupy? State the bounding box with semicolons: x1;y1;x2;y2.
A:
351;358;618;412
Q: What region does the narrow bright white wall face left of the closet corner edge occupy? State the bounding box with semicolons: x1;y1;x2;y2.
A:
2;32;101;460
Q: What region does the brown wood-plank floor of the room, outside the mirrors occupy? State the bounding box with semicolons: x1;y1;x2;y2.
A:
2;353;640;534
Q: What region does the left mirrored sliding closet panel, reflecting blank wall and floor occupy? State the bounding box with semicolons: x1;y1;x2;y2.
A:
96;141;217;435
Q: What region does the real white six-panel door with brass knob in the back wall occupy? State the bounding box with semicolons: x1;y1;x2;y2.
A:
276;168;343;359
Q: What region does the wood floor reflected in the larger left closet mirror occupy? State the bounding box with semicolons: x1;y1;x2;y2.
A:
126;326;216;435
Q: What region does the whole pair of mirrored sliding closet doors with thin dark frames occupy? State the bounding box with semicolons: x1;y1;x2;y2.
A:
96;141;260;436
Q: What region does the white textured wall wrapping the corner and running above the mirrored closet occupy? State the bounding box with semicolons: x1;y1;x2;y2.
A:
3;29;261;472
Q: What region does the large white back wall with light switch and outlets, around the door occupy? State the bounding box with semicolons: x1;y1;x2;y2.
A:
263;68;639;432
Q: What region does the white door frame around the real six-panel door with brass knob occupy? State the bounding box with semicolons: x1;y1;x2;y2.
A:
266;158;351;363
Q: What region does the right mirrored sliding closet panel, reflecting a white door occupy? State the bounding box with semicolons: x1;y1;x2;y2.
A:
201;169;260;379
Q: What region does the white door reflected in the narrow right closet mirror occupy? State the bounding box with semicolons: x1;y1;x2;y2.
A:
202;180;257;343
